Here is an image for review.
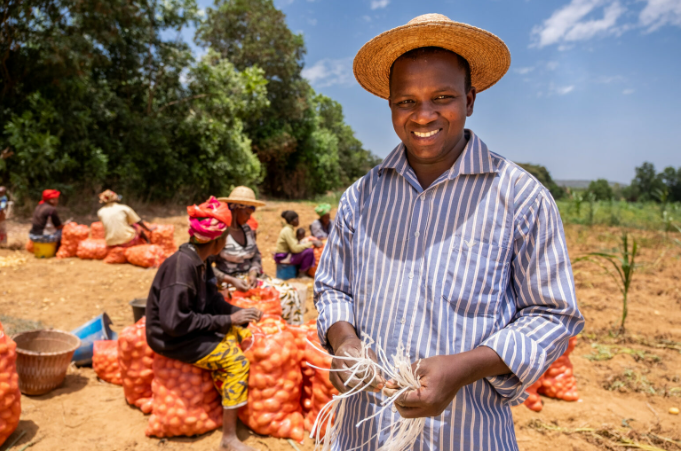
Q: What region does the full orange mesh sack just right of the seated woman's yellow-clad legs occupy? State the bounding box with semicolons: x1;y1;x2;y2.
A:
239;316;304;442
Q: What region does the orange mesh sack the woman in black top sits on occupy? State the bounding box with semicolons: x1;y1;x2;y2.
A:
144;354;222;437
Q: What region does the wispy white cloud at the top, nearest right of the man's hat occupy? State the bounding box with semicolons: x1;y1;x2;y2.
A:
532;0;626;50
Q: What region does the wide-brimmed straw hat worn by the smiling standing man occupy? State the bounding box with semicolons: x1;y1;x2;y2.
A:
353;14;511;99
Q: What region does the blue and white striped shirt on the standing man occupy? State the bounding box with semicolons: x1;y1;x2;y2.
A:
315;131;584;450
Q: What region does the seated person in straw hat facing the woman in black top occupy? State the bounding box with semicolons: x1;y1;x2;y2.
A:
214;187;304;325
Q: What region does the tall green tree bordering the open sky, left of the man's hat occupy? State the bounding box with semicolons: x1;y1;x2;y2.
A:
197;0;376;198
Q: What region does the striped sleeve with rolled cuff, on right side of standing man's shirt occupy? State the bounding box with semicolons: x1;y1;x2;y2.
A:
482;191;584;405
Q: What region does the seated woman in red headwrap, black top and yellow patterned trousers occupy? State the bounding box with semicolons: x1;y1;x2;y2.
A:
146;197;262;450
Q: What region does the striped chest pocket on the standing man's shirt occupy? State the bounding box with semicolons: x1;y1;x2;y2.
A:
443;236;509;318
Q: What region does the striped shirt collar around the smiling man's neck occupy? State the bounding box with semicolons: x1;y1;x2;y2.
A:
378;129;498;179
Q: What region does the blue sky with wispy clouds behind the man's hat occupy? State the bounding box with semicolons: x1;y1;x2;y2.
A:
186;0;681;183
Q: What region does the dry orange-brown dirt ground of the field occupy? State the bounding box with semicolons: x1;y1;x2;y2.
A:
0;202;681;450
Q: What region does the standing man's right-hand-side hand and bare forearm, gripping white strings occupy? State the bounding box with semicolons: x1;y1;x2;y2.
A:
384;346;510;418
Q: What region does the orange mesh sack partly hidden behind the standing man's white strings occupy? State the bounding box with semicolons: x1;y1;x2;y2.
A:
305;329;338;437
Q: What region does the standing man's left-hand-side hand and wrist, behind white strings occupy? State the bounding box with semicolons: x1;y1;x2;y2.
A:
327;321;385;393
